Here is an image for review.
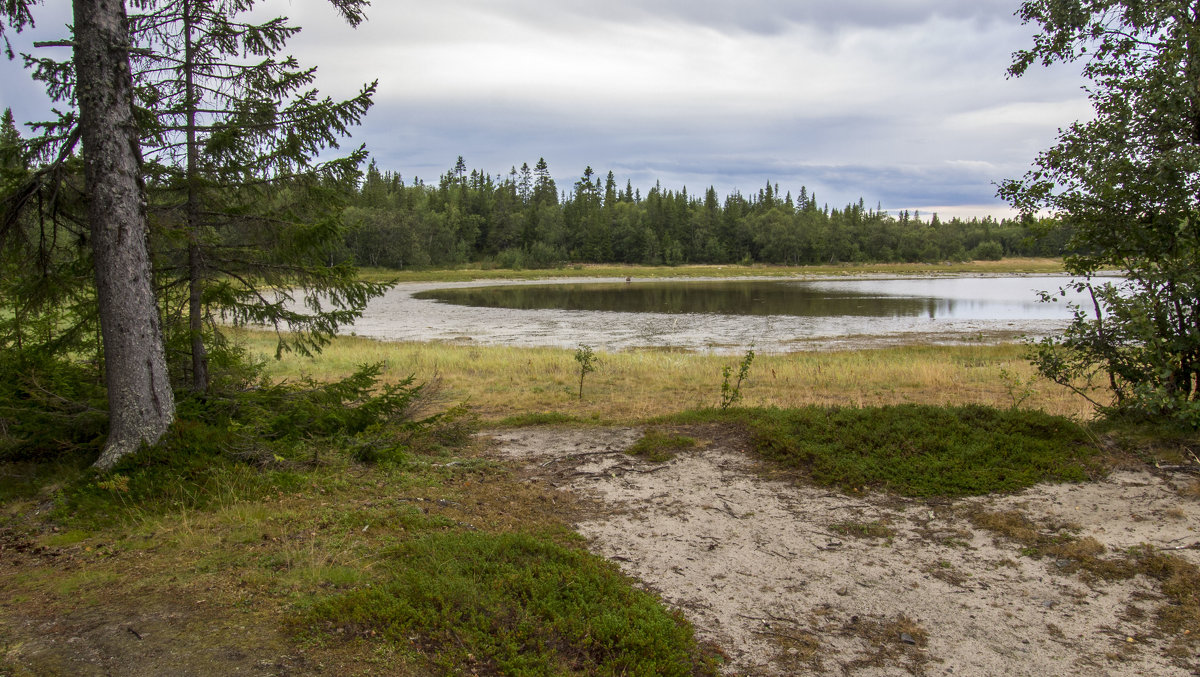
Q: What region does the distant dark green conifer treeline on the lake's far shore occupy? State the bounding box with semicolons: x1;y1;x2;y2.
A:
340;157;1069;269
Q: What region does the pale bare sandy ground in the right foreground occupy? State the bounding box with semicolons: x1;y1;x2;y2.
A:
491;427;1200;677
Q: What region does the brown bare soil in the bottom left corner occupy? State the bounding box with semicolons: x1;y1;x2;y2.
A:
0;529;348;677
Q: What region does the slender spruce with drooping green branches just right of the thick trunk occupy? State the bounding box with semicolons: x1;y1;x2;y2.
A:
124;0;382;391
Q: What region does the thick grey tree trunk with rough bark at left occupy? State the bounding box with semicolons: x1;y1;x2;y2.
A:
74;0;175;469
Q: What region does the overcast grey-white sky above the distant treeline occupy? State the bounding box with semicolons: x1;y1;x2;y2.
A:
0;0;1091;216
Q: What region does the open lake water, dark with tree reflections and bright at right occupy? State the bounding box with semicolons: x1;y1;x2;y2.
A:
414;277;1069;319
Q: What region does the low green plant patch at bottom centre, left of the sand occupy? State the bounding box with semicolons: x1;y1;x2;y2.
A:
306;533;715;676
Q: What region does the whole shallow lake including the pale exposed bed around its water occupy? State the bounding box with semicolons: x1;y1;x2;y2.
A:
352;275;1104;353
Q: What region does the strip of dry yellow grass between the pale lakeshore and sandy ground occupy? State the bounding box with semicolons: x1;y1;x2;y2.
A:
239;331;1092;420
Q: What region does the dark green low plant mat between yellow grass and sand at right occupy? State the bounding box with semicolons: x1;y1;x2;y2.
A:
679;405;1099;496
